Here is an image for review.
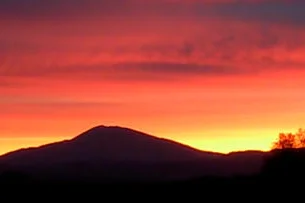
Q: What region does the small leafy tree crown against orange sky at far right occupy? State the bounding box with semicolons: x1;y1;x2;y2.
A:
272;128;305;149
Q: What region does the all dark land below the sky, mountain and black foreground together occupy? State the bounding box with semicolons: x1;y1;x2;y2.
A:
0;127;305;198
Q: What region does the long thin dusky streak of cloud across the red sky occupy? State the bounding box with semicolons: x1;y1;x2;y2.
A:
0;62;243;80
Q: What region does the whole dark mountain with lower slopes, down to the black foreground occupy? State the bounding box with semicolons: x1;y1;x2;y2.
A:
0;126;265;181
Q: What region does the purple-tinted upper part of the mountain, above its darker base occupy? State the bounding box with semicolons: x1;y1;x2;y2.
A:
0;126;218;164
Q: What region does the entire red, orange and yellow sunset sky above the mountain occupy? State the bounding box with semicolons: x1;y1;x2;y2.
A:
0;0;305;154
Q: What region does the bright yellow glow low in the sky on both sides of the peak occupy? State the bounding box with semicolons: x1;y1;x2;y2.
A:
0;129;288;154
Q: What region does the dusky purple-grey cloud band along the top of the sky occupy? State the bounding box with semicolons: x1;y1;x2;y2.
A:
0;0;305;25
